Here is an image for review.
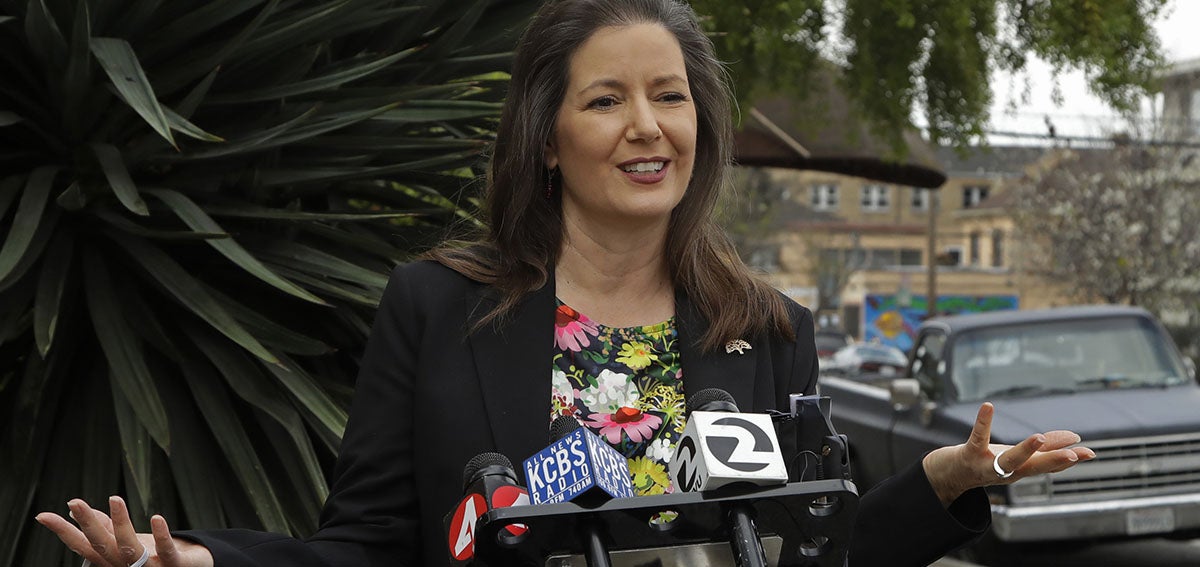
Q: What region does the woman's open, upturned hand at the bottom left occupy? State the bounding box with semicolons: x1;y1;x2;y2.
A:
36;496;212;567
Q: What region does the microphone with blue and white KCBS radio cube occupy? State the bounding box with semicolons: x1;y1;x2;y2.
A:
523;416;634;506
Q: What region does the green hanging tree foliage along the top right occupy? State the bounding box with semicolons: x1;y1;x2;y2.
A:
692;0;1166;148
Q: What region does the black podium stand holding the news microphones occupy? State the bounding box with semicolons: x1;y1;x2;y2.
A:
474;479;858;567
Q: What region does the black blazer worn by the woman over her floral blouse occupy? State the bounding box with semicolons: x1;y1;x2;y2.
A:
178;262;990;567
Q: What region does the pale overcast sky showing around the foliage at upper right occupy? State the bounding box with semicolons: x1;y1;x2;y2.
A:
991;0;1200;144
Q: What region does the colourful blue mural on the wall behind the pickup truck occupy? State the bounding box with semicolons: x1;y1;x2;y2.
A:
863;294;1018;352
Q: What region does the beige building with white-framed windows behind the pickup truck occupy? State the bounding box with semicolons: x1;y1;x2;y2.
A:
757;147;1066;339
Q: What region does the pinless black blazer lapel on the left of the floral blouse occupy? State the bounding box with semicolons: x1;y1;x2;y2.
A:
468;276;554;468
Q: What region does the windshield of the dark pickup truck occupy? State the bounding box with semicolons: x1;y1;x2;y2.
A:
950;317;1187;401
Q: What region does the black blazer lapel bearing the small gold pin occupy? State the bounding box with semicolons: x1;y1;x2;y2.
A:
676;293;762;412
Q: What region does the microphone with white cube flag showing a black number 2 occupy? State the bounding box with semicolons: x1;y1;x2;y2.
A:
671;388;787;567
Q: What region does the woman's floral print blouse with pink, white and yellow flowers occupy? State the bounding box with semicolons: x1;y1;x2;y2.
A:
550;302;685;496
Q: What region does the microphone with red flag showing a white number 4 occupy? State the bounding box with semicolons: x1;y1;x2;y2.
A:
443;453;529;565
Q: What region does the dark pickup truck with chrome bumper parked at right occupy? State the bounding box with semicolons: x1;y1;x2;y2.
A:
818;305;1200;542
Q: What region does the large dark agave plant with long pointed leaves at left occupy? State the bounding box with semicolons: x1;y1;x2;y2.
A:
0;0;532;565
